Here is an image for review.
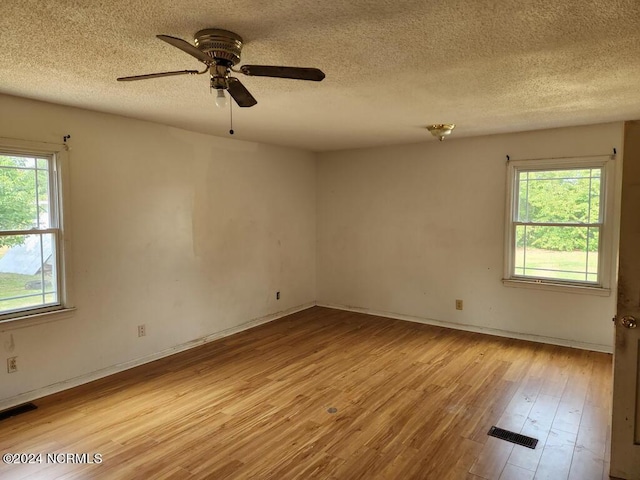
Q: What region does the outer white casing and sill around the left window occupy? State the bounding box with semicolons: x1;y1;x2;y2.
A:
0;137;75;327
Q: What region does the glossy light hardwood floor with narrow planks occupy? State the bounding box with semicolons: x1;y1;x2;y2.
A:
0;307;611;480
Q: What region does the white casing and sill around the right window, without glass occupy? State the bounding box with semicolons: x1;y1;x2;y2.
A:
502;155;616;296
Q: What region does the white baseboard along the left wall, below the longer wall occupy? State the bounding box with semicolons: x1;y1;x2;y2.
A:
0;302;315;411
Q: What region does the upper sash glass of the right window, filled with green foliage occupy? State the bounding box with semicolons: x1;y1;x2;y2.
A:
516;168;602;224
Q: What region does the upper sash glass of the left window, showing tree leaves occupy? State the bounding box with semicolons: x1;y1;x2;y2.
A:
0;155;51;230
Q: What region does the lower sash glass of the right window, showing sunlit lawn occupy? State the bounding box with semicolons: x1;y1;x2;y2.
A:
514;225;600;283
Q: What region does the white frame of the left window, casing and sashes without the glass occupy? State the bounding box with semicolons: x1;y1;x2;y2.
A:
0;138;75;325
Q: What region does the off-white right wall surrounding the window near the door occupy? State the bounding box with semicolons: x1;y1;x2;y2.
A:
317;123;623;351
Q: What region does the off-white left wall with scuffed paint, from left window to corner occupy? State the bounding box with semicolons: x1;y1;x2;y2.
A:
0;96;316;406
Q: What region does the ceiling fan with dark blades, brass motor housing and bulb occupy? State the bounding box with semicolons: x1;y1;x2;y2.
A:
118;28;324;107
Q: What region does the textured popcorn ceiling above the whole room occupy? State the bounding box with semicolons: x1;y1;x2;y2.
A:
0;0;640;151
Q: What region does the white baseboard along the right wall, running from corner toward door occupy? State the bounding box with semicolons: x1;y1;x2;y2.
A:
316;303;613;353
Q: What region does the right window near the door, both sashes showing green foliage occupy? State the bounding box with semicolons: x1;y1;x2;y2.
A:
505;157;613;289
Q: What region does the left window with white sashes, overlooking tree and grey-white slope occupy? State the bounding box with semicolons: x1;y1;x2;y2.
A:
0;143;66;321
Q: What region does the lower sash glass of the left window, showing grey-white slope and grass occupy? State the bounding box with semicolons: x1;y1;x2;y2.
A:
0;234;59;313
